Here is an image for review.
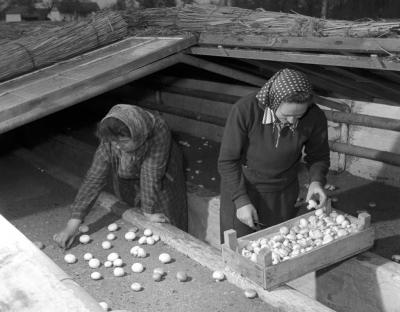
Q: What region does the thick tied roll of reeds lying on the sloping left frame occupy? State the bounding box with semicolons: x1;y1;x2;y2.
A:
0;12;127;81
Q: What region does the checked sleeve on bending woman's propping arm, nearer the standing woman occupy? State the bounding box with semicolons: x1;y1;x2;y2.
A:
140;121;171;213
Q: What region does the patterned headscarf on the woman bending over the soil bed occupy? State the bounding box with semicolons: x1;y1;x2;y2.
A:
101;104;156;177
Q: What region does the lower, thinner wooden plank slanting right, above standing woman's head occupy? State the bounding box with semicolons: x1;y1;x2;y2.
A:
190;47;400;71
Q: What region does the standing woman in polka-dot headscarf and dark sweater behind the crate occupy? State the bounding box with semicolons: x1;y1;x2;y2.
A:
218;69;329;239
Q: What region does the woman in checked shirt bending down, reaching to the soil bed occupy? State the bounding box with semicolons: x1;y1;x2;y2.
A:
54;104;187;248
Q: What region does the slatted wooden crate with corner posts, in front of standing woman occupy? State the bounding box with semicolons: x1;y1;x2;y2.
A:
222;209;374;290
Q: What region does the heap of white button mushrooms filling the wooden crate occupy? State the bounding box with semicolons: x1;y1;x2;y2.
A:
242;209;358;264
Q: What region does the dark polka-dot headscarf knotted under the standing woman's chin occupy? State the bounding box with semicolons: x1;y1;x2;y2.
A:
256;68;312;148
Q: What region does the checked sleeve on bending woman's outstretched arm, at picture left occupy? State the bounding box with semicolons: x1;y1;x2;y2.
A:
71;143;110;220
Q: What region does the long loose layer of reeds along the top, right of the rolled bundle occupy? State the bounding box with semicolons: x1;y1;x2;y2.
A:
125;5;400;37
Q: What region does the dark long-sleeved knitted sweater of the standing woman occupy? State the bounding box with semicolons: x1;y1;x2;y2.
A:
218;94;330;208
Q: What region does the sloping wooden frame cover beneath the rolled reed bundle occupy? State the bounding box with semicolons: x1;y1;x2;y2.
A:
0;37;196;133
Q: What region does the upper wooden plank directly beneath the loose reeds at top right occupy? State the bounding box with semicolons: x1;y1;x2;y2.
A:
199;32;400;55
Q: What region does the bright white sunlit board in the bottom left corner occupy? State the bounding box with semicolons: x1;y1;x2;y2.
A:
0;215;102;312
